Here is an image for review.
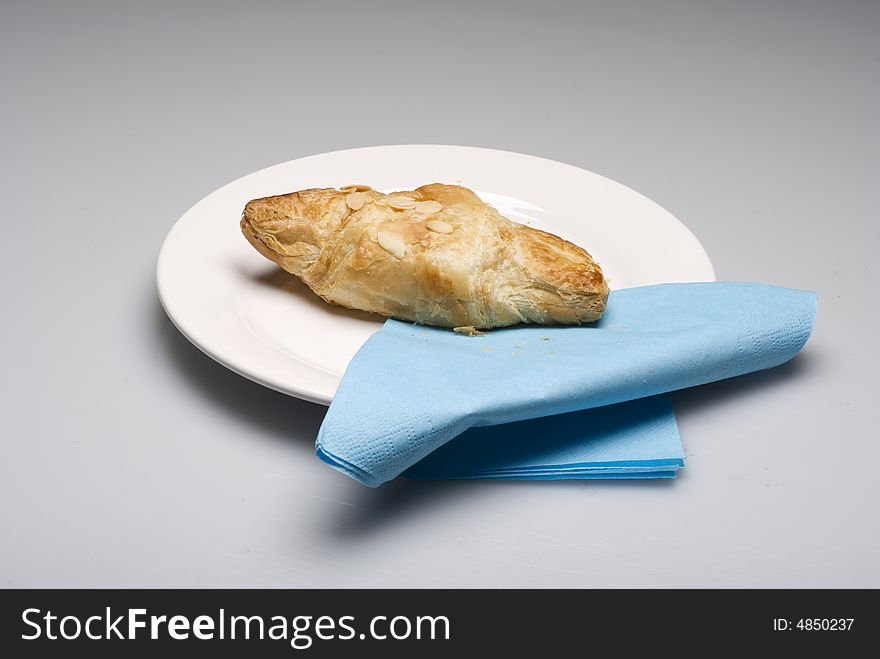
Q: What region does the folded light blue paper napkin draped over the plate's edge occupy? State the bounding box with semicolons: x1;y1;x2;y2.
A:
317;282;816;487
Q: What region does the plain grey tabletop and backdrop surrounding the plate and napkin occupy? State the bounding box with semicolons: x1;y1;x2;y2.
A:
0;1;880;587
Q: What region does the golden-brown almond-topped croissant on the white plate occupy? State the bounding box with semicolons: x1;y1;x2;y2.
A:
241;183;608;329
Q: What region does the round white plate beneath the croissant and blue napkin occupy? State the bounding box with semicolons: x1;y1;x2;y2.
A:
156;145;715;405
